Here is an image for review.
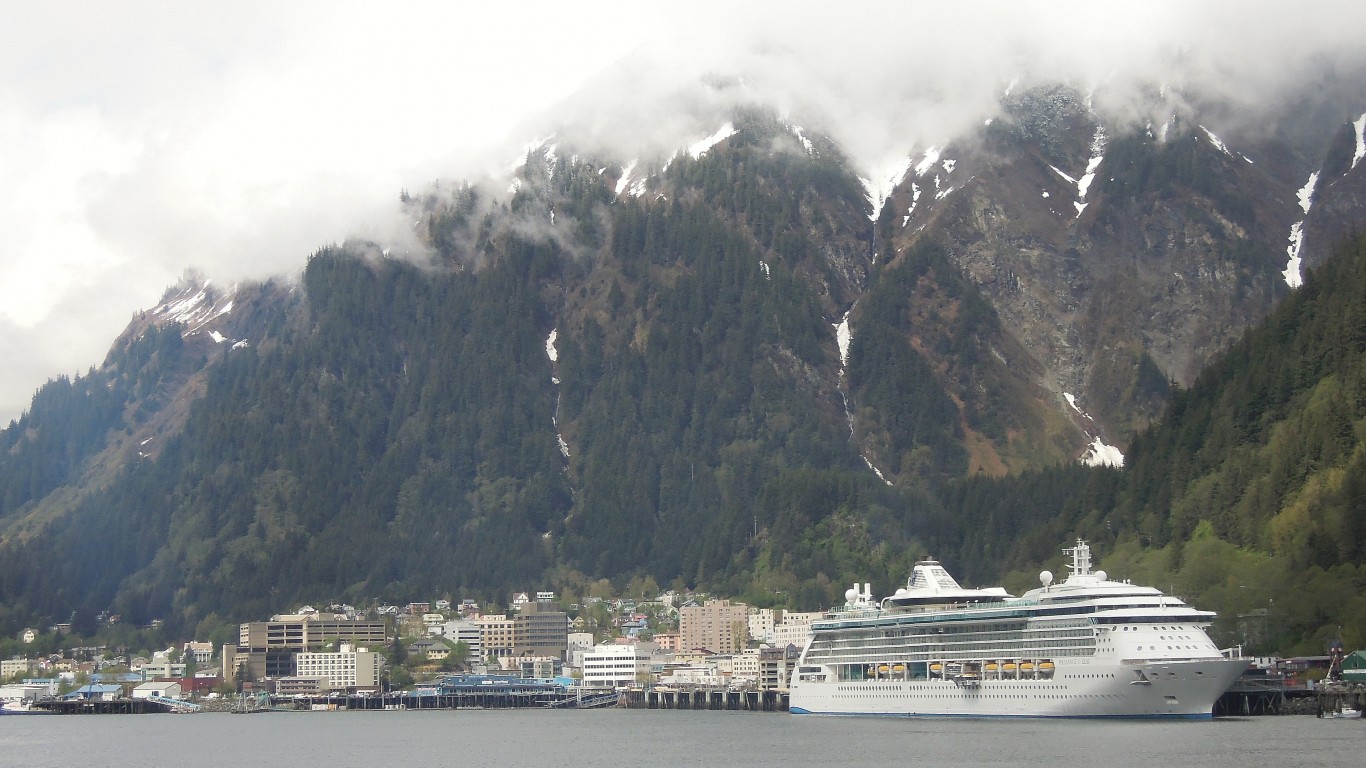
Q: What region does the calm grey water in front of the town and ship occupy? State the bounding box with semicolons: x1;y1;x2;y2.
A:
0;709;1366;768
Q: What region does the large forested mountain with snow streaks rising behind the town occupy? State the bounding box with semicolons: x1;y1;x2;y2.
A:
0;85;1366;645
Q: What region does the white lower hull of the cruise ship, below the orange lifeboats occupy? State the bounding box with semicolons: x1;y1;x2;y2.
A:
791;650;1247;719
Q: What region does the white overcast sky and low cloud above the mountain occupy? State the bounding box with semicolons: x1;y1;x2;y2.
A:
0;0;1366;424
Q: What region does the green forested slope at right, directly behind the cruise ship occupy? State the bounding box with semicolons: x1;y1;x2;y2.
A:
933;238;1366;653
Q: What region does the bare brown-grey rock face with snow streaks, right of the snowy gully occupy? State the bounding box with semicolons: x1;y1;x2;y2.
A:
889;85;1327;444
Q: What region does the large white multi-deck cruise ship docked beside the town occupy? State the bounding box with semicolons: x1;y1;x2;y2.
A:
791;540;1249;719
